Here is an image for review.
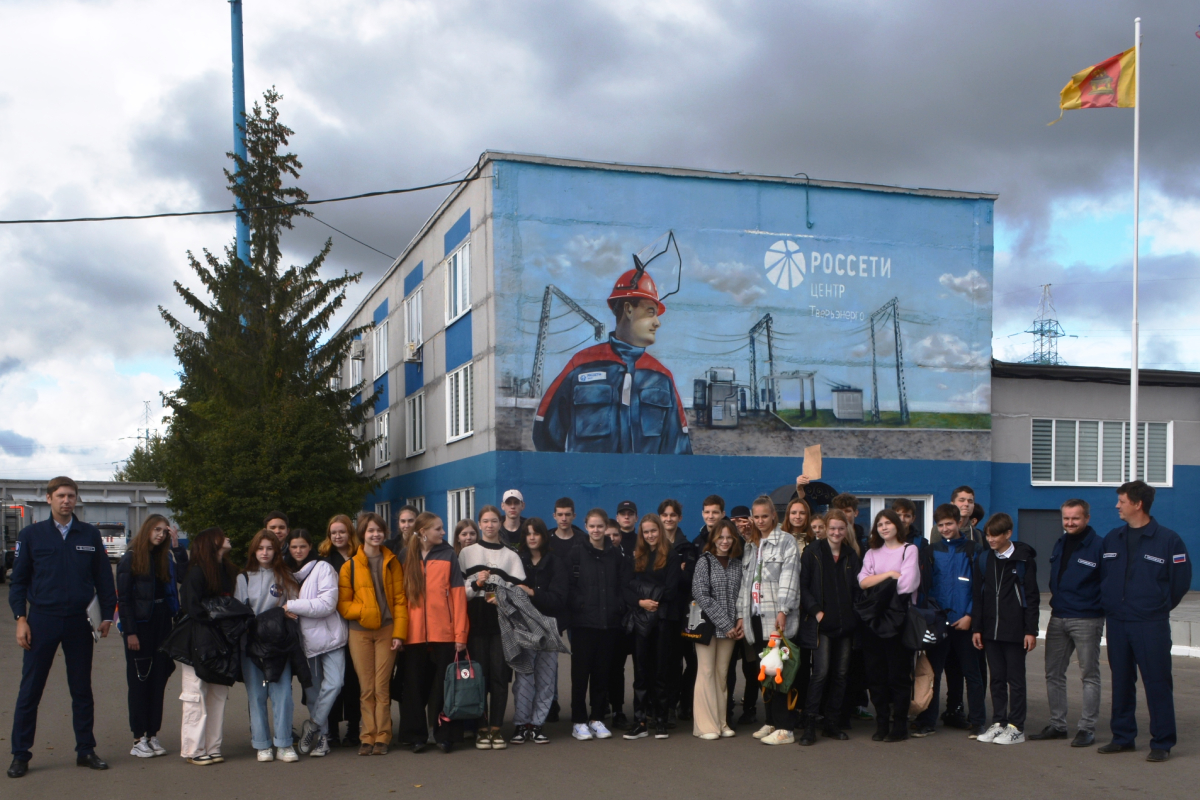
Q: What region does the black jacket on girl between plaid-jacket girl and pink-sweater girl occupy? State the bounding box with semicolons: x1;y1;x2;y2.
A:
799;539;863;650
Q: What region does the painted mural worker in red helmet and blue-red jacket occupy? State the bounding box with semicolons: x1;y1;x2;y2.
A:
533;265;691;455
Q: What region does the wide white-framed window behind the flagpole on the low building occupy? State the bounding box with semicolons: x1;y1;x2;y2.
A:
1030;419;1174;486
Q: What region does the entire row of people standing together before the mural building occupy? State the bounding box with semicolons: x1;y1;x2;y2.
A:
10;479;1190;777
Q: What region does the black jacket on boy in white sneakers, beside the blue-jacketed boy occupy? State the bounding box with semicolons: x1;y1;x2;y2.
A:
971;542;1042;642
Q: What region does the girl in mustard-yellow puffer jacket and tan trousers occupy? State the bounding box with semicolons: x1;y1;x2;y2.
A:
337;513;408;756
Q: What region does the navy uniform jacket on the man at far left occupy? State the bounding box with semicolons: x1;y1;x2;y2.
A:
8;517;116;620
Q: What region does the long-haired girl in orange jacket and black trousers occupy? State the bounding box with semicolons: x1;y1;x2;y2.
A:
400;512;469;753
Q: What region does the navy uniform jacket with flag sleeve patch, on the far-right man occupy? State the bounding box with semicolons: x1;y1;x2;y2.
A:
1100;517;1192;622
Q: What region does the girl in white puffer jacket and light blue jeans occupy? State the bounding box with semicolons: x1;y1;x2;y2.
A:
283;529;349;756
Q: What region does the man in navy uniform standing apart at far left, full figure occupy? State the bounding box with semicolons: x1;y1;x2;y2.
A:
8;477;116;777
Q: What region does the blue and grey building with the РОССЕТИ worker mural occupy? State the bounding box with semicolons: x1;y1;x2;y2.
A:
342;151;1200;587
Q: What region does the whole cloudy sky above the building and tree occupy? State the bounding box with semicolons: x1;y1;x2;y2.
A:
0;0;1200;479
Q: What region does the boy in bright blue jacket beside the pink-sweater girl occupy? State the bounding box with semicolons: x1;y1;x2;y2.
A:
912;503;988;739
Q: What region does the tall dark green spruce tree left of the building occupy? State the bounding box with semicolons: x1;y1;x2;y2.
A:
160;89;371;552
